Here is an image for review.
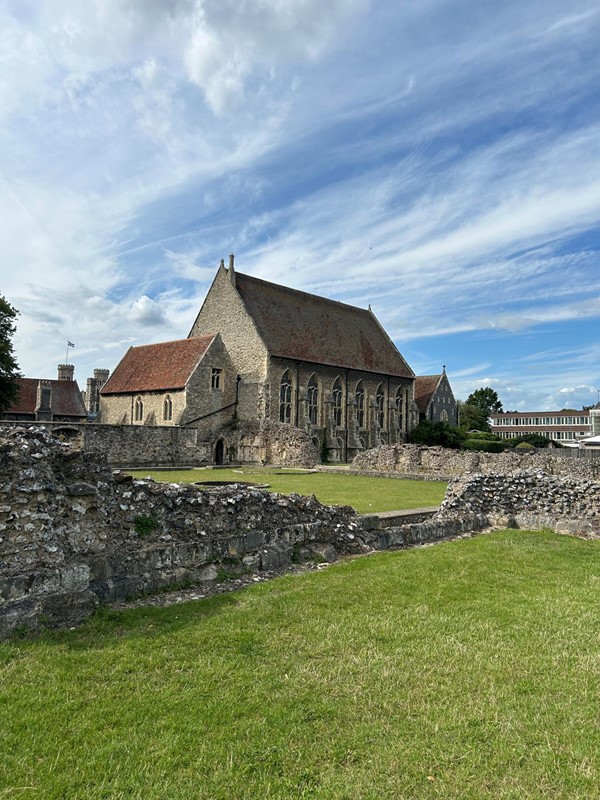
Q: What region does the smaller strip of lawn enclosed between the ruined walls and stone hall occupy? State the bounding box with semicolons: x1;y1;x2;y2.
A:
131;467;447;514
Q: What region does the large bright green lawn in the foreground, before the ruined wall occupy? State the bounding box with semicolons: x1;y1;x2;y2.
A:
0;531;600;800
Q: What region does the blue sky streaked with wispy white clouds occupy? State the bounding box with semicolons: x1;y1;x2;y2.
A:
0;0;600;411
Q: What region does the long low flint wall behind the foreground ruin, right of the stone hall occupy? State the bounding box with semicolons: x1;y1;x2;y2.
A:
352;444;600;480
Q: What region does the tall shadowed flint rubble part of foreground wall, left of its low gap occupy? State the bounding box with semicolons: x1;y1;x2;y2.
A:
0;428;346;635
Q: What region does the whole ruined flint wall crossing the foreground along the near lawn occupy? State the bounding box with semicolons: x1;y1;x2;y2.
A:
0;427;600;637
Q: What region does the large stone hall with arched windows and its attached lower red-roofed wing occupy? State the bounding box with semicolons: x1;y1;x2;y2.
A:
98;256;426;462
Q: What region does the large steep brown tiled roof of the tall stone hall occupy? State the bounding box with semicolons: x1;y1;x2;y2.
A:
235;272;414;378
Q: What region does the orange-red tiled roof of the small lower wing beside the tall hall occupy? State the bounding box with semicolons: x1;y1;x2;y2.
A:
100;334;215;395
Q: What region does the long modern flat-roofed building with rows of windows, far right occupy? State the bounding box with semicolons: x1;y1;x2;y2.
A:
491;408;592;443
